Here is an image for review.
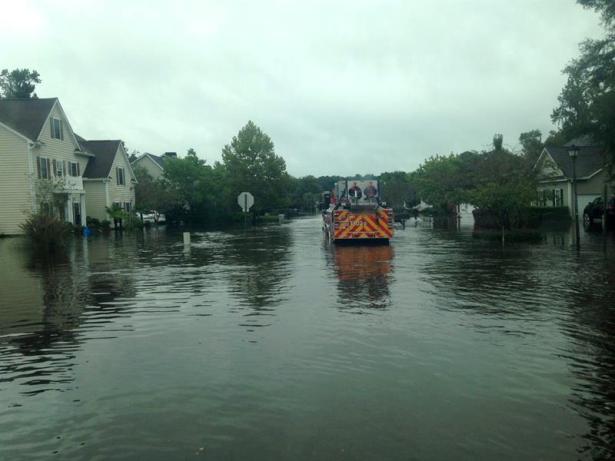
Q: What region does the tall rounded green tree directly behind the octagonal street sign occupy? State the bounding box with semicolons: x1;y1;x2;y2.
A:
222;121;290;212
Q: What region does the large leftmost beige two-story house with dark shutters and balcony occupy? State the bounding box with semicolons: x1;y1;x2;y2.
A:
0;98;92;234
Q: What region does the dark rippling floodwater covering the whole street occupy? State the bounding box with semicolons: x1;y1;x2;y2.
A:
0;218;615;461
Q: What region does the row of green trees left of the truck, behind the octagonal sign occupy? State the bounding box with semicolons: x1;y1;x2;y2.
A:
133;121;352;225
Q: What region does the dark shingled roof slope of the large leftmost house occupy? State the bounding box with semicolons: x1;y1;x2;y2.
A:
0;98;58;141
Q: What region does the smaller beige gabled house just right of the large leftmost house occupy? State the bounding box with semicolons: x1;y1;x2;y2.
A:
79;138;137;221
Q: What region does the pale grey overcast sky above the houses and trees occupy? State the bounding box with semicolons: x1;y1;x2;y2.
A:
0;0;602;176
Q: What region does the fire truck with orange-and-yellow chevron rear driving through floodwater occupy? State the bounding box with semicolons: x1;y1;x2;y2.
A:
323;180;393;243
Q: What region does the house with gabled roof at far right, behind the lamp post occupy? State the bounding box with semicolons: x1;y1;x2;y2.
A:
534;142;612;216
